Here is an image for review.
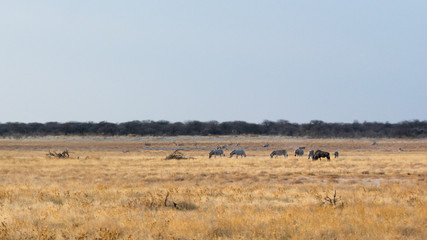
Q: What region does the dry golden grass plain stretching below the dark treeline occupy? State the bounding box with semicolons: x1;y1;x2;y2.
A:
0;136;427;239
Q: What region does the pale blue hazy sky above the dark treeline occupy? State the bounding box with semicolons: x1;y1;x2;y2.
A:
0;0;427;123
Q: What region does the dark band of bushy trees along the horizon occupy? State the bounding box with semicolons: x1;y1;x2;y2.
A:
0;120;427;138
